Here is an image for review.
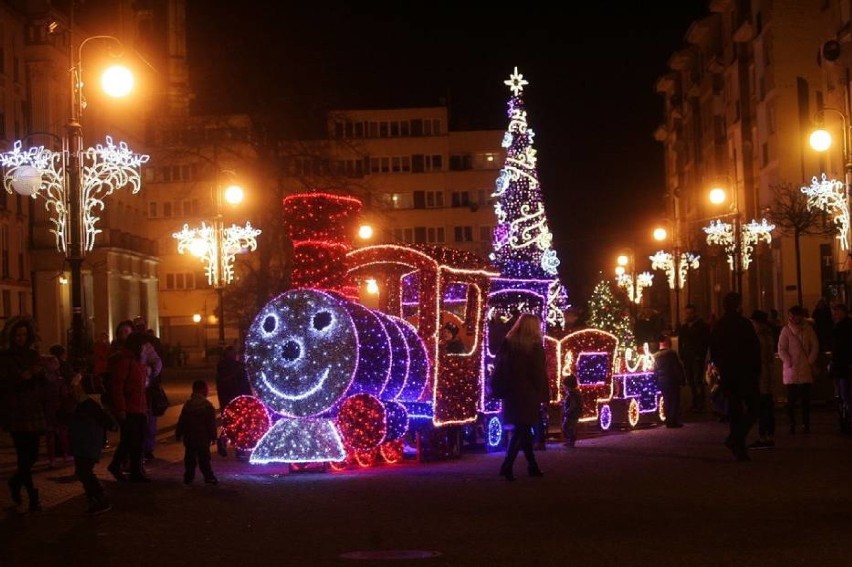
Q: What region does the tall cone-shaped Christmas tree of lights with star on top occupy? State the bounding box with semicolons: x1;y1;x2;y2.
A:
490;67;568;328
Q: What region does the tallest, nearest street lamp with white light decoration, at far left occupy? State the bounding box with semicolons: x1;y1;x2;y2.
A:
0;35;149;364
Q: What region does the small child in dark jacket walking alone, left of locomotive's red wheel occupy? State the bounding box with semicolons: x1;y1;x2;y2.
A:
175;380;219;484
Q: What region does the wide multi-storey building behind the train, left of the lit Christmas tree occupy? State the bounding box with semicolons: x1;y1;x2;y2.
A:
285;107;505;257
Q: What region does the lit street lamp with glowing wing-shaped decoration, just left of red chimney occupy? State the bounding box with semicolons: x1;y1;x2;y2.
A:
172;175;261;349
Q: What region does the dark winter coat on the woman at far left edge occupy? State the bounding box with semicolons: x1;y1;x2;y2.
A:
0;348;48;433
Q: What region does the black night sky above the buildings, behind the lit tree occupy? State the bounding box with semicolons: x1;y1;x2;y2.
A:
187;0;709;304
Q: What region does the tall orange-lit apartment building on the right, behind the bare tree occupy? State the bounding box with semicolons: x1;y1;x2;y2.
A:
655;0;832;314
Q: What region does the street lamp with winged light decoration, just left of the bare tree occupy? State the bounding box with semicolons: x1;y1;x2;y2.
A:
704;187;775;293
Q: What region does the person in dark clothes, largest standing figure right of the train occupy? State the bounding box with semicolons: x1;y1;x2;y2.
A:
710;292;760;461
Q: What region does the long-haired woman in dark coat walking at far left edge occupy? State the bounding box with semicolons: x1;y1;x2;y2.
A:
0;319;47;512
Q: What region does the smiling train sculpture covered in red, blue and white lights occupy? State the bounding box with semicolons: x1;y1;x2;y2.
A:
223;245;664;468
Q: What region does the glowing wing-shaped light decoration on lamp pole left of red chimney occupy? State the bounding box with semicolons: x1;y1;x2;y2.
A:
172;222;261;286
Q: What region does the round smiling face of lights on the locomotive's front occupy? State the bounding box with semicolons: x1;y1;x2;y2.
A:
245;289;358;417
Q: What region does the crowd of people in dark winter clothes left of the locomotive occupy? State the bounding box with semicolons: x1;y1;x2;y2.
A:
0;317;250;514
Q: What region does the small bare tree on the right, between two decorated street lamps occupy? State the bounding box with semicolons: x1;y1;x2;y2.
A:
770;183;836;305
